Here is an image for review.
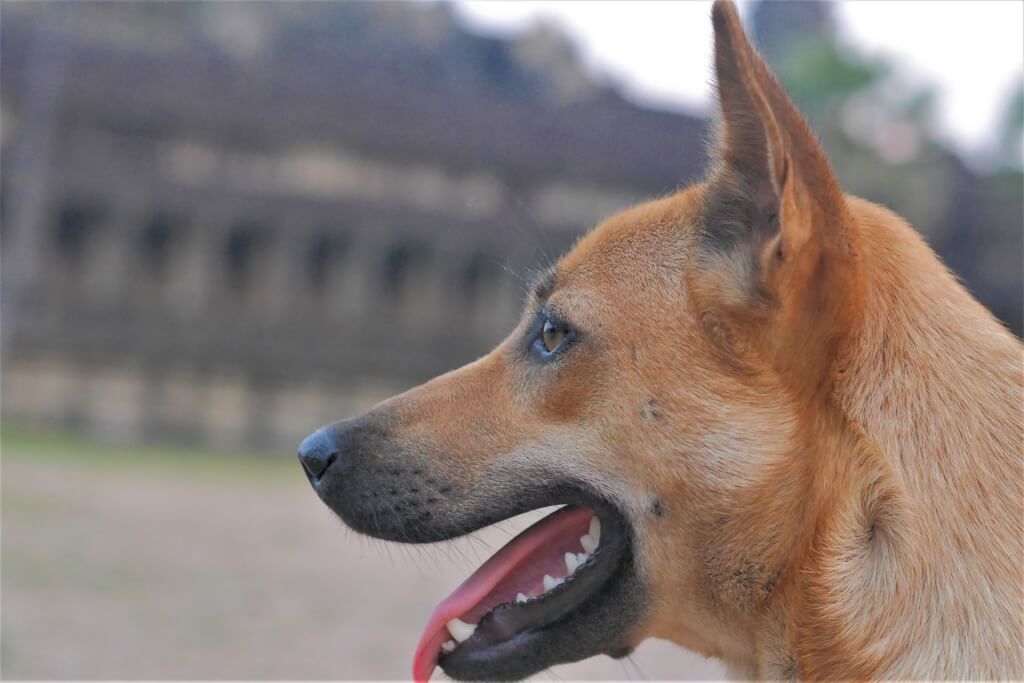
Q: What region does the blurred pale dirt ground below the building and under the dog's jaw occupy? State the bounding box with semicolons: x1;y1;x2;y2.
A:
0;429;722;680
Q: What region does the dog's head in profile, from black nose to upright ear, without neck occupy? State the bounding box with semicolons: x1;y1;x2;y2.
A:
300;3;859;679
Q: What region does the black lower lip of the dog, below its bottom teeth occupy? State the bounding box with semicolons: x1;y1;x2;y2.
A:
438;505;635;680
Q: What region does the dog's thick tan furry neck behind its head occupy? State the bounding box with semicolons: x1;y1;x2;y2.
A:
754;200;1024;678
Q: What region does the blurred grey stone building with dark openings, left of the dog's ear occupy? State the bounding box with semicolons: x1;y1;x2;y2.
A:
0;2;703;447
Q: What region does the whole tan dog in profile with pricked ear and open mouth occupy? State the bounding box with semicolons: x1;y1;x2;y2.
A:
299;1;1024;681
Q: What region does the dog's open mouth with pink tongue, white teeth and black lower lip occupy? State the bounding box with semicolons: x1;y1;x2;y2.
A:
413;506;631;681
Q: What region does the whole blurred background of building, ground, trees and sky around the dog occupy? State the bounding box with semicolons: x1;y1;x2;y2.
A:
0;0;1024;680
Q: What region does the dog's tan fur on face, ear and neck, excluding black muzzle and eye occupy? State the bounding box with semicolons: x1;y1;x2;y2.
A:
364;3;1024;679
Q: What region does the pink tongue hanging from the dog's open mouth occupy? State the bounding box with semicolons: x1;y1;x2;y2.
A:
413;507;594;682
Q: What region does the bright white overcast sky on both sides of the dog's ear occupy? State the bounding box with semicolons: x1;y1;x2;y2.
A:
455;0;1024;166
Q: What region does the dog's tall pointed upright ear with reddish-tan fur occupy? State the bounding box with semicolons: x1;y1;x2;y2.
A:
699;0;859;385
